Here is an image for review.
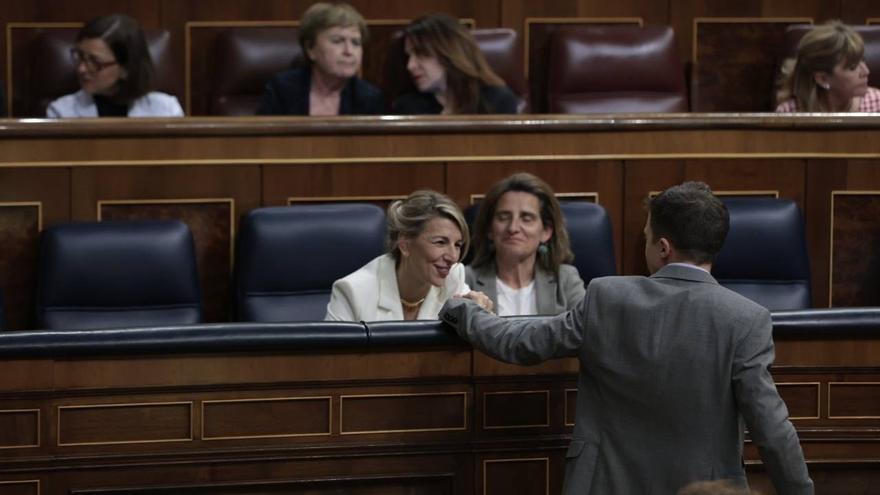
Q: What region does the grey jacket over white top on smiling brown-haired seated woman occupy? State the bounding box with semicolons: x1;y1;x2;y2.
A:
465;263;586;315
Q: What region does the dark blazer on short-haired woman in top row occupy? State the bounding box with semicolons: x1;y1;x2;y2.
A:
257;67;385;115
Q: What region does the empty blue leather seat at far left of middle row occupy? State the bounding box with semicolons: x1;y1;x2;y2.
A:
37;220;202;330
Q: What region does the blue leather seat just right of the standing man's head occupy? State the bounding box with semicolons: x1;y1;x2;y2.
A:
712;198;811;311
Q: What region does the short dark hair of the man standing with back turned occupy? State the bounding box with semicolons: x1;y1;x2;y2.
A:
648;182;730;263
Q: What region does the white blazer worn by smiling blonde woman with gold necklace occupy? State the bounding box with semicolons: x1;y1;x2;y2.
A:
324;254;470;321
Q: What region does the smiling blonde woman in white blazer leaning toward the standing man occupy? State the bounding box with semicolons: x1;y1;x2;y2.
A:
325;190;491;321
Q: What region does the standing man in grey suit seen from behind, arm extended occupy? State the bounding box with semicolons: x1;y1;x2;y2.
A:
440;182;813;495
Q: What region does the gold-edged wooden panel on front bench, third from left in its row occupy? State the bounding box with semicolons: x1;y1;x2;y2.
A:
202;397;330;440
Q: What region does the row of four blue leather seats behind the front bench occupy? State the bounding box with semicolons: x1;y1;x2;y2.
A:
20;198;810;330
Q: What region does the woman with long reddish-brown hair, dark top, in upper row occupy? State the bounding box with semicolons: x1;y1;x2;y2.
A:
392;14;519;115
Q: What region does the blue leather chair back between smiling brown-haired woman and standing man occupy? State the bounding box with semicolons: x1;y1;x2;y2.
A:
560;201;617;284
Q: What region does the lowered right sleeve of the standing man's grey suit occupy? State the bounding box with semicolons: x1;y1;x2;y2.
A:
733;310;813;495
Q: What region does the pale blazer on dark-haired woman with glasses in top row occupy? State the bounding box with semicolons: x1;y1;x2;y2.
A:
46;90;183;119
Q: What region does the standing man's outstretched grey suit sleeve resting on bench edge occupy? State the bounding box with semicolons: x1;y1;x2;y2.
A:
440;292;586;365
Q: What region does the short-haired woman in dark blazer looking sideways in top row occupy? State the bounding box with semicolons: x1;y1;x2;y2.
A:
257;2;384;116
